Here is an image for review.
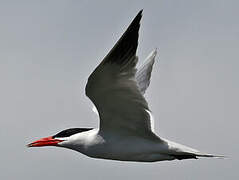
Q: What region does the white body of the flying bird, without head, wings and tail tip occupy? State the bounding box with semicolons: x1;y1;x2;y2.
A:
60;129;202;162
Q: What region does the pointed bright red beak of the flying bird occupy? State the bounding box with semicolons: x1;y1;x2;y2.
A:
27;136;63;147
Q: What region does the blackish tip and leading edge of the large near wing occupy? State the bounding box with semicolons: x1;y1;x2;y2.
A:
85;10;143;100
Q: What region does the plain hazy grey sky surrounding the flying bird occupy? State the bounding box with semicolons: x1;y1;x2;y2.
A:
0;0;239;180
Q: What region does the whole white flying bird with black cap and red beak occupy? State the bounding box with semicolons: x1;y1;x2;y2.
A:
28;10;220;162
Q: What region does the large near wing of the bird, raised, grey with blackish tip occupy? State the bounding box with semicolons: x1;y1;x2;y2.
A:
86;11;157;136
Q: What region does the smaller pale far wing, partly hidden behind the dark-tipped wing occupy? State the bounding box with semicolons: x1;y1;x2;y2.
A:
135;49;157;94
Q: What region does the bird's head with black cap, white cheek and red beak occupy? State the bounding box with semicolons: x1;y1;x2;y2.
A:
27;128;93;147
